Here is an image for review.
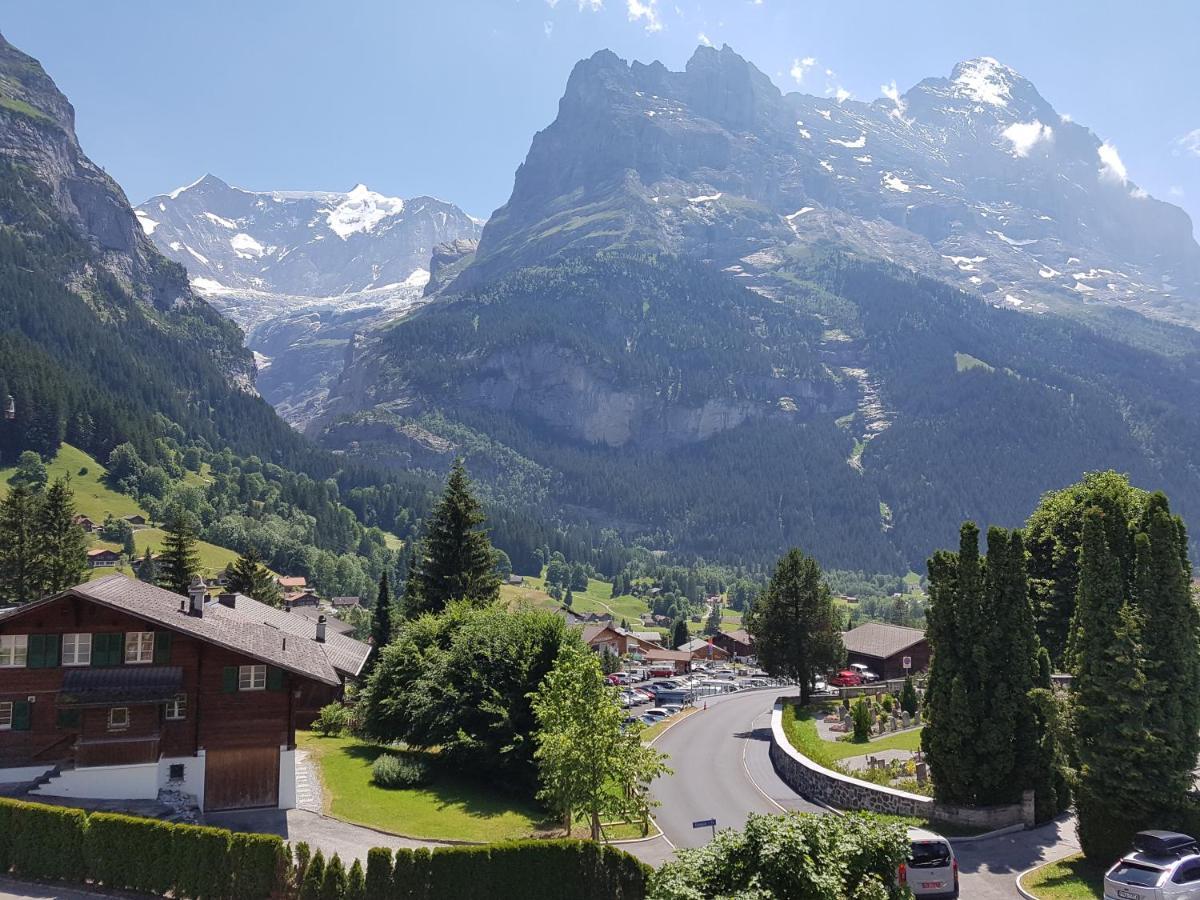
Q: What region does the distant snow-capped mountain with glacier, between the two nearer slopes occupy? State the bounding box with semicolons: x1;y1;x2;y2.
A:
136;175;480;428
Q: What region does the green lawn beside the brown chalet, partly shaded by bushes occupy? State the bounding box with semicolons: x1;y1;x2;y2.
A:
296;732;545;841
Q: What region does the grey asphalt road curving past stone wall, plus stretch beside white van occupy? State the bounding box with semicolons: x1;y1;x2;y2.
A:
624;688;1079;900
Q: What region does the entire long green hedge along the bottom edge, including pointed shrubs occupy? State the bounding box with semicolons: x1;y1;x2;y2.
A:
0;798;650;900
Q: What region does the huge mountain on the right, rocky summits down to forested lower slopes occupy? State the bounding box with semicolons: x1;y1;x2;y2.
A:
307;48;1200;571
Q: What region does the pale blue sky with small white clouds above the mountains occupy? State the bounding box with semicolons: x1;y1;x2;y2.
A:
0;0;1200;221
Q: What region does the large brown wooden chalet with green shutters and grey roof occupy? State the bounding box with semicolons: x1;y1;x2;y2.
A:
0;574;370;810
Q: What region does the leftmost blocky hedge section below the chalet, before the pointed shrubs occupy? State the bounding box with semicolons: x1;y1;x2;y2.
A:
0;798;288;900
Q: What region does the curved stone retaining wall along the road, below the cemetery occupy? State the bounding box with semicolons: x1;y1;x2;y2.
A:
770;700;1033;830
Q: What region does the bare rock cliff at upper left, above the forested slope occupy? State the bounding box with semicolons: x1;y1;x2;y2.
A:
0;30;254;391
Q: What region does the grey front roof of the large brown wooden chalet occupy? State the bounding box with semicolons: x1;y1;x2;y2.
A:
4;574;341;685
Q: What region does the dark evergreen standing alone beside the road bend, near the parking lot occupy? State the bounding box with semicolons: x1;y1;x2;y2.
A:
744;548;845;703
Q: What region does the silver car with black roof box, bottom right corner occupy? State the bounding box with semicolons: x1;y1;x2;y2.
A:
1104;832;1200;900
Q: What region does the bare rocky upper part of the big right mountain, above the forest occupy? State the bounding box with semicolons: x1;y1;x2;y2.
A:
463;47;1200;324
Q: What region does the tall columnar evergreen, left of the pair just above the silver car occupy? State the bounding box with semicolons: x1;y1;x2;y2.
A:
1072;508;1164;862
